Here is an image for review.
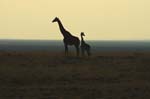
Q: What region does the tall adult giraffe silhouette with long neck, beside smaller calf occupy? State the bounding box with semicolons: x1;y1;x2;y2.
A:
52;17;80;56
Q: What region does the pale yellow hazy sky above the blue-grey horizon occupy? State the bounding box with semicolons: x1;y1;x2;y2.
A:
0;0;150;40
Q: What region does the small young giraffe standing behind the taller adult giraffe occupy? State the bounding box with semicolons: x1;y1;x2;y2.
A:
80;32;91;56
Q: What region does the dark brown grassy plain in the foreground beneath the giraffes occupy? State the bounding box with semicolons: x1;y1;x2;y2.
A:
0;51;150;99
